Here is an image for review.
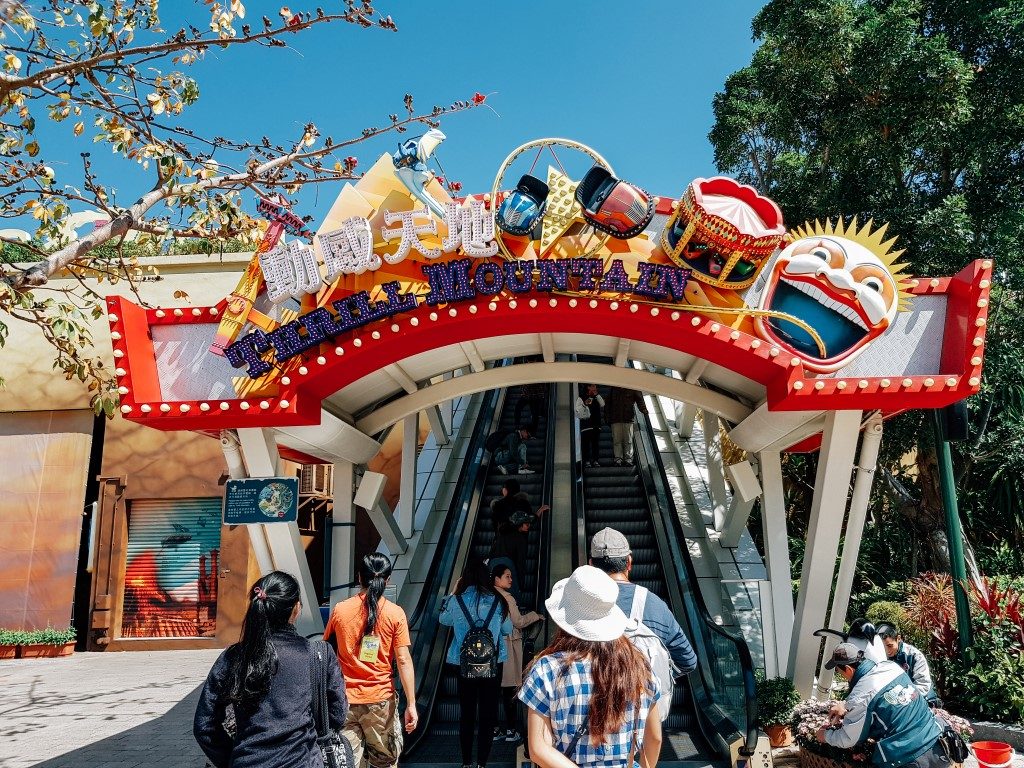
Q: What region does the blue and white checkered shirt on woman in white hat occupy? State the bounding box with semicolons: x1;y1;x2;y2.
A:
519;653;662;768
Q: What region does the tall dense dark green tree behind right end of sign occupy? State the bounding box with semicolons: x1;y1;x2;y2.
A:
710;0;1024;575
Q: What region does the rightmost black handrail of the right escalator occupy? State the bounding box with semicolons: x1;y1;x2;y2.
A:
634;412;758;756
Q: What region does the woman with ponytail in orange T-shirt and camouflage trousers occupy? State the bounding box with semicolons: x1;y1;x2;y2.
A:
324;552;419;768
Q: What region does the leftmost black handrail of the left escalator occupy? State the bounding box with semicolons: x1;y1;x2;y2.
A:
403;376;505;754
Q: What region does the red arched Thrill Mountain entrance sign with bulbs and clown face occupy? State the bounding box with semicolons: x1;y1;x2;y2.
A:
108;139;992;449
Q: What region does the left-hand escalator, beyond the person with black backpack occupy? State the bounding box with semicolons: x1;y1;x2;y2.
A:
402;390;554;765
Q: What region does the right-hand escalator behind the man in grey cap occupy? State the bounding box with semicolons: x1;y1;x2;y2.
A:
574;387;756;765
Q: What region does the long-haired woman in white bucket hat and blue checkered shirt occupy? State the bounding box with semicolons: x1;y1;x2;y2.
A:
519;565;662;768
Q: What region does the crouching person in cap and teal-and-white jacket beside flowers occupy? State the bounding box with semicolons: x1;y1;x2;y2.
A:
815;643;949;768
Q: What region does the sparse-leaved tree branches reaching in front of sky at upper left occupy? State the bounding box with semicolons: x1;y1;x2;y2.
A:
0;0;483;415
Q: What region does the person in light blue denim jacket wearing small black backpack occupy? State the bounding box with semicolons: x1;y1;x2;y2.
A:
438;559;513;768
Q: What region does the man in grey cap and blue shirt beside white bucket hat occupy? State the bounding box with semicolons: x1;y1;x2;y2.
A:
590;528;697;675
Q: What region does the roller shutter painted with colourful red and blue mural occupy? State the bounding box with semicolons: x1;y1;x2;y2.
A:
121;498;222;638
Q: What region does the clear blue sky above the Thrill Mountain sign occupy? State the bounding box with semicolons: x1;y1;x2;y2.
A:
32;0;763;227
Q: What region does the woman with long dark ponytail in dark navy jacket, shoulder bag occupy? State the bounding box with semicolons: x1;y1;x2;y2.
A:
193;570;348;768
